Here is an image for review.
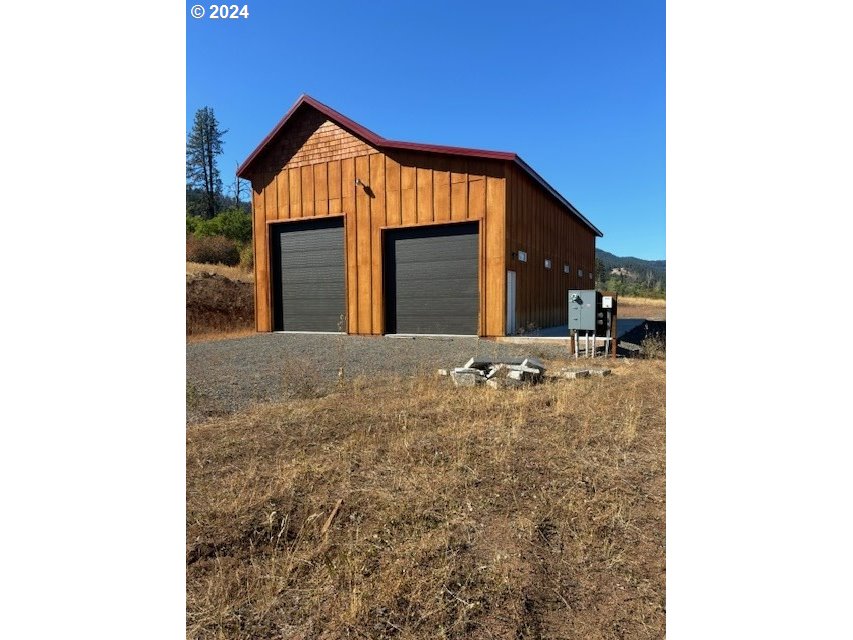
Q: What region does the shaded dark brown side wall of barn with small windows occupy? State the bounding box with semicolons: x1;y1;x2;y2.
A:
506;166;595;328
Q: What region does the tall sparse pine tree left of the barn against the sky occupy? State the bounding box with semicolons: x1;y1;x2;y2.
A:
187;107;228;218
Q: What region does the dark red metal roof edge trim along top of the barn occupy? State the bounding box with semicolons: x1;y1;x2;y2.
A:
237;93;604;238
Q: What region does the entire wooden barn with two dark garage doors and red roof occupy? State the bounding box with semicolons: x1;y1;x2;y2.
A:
237;95;602;336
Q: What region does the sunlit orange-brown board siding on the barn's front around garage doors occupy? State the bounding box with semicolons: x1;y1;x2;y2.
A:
246;126;507;336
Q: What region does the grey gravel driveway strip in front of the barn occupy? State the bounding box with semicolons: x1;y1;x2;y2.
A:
187;333;566;422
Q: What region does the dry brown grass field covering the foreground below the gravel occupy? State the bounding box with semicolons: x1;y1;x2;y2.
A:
187;360;665;640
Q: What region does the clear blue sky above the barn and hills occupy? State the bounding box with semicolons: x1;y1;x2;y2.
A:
186;0;666;259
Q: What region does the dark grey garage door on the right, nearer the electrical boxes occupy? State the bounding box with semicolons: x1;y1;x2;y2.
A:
385;223;480;335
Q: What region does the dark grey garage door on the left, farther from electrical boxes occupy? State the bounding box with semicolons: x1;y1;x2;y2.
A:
270;218;346;331
